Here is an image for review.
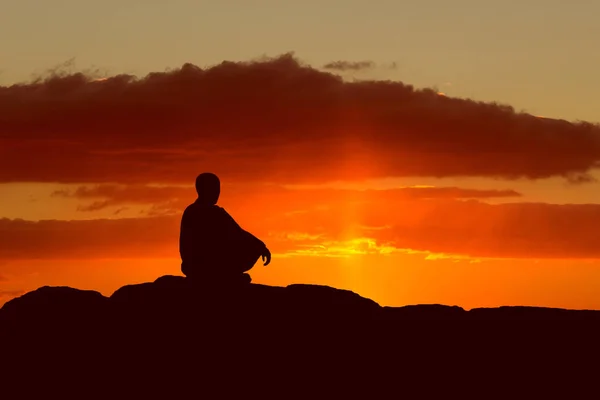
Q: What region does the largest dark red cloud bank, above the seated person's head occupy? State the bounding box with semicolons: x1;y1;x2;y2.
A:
0;55;600;184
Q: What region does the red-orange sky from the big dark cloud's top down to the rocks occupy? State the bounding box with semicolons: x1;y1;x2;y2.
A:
0;56;600;309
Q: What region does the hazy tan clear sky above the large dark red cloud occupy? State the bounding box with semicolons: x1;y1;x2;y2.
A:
0;0;600;121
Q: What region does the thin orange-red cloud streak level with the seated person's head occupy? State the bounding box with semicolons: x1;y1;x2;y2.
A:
53;184;521;213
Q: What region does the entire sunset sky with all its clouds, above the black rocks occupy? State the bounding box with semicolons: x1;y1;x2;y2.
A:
0;0;600;309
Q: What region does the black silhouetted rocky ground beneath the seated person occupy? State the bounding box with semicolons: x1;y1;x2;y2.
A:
0;276;600;398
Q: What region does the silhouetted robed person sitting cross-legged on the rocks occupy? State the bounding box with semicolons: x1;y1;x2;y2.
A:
179;173;271;283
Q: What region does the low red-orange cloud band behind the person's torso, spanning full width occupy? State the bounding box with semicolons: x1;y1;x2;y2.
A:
0;193;600;259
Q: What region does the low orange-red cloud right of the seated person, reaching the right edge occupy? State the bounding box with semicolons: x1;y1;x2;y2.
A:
272;200;600;259
